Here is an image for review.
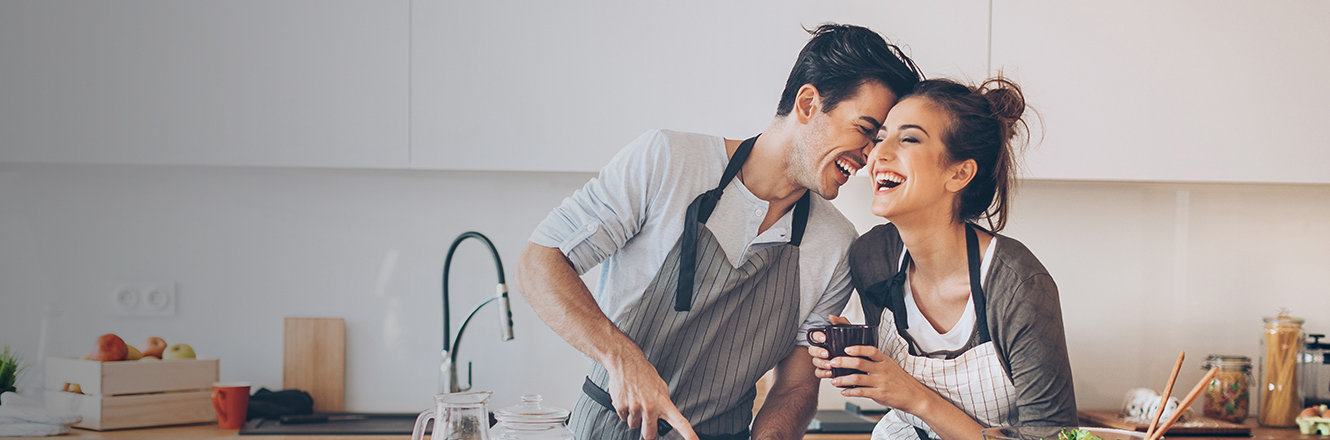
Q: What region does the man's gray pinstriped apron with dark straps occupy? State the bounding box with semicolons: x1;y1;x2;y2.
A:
569;137;809;440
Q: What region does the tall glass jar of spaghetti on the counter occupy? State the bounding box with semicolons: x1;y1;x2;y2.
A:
1257;308;1306;428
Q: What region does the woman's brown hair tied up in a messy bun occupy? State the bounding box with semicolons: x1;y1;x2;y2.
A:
907;74;1029;233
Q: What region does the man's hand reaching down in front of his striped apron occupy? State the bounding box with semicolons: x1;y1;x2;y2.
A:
606;359;697;440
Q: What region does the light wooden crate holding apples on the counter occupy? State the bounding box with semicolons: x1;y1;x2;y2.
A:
45;358;218;431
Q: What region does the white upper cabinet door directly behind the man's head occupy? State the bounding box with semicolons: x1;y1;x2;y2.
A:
411;0;988;171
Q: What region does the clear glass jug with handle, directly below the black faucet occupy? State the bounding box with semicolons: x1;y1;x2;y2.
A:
411;391;489;440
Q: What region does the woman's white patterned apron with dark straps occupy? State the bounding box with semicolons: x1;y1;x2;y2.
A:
866;226;1016;440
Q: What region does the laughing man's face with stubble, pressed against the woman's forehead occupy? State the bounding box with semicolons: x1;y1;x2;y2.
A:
787;82;896;199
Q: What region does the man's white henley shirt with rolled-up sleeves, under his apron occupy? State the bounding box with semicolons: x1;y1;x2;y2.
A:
531;130;859;346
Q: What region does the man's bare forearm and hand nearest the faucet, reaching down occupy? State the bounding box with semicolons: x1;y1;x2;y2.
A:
513;243;702;440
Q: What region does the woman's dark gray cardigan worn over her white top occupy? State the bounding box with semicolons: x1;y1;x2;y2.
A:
850;223;1077;425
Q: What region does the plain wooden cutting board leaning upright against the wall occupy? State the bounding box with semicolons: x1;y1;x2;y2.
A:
282;318;346;412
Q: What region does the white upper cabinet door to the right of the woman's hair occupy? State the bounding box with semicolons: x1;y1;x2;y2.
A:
992;0;1330;183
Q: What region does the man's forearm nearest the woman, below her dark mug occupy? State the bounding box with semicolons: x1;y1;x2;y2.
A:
753;347;818;440
